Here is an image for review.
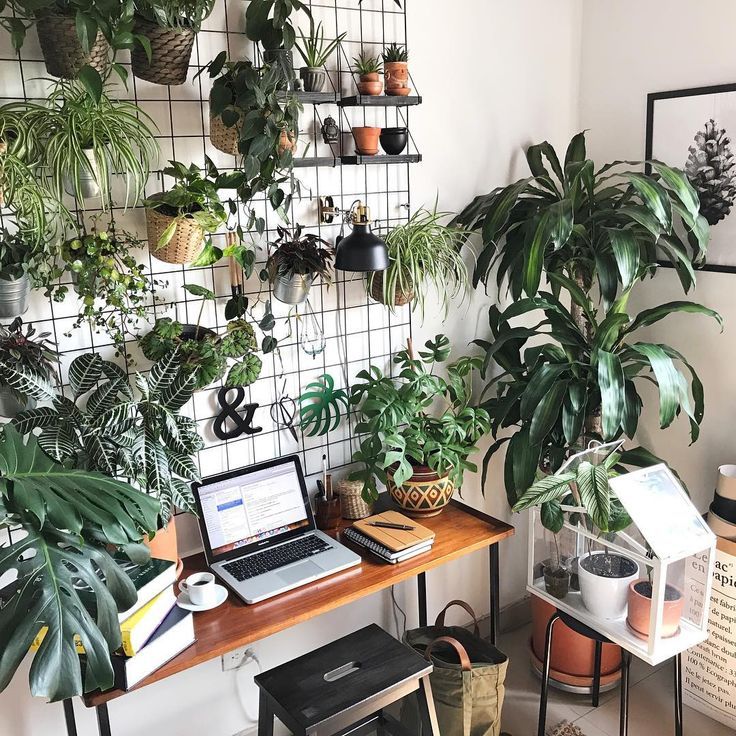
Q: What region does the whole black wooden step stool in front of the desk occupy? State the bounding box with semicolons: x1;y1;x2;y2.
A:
255;624;440;736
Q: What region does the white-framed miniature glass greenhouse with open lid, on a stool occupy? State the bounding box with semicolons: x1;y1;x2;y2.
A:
527;450;716;664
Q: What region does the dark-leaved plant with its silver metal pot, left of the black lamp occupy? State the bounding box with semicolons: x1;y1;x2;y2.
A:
266;225;335;304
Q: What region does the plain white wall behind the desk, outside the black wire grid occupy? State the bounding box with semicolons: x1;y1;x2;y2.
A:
0;0;581;736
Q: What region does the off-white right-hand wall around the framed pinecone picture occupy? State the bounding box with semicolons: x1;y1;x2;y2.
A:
580;0;736;510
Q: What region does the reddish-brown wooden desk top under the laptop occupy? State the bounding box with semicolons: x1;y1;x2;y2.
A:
84;501;514;706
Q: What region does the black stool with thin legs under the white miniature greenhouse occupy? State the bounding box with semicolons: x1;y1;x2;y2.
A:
537;609;682;736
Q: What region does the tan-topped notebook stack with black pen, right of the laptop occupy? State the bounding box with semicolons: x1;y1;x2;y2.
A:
343;511;434;565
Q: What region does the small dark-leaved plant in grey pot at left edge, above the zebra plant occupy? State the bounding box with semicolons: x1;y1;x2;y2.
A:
0;317;58;417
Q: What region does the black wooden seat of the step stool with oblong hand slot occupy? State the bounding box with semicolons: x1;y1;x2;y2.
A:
255;624;432;733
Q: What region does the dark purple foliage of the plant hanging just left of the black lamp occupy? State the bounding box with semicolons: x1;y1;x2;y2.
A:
266;225;335;285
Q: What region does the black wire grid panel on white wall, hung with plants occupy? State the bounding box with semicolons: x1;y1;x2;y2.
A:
0;0;411;494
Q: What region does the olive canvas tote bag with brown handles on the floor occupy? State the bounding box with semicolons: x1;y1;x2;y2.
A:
401;601;508;736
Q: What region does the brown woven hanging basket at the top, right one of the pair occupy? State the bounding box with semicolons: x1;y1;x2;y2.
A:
130;18;195;84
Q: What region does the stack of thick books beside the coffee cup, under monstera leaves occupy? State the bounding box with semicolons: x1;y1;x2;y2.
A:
32;559;195;690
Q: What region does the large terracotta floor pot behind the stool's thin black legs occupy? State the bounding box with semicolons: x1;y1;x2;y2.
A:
532;595;621;684
